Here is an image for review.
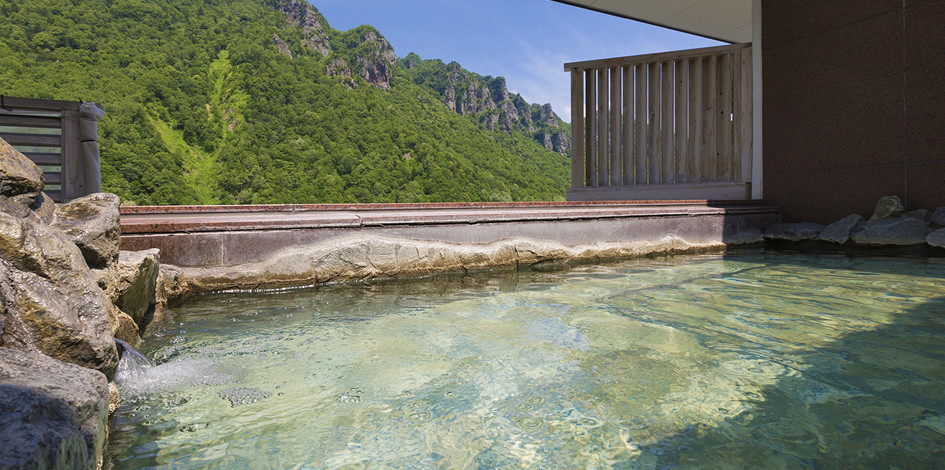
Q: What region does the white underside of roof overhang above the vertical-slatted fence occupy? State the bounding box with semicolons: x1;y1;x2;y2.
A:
553;0;752;43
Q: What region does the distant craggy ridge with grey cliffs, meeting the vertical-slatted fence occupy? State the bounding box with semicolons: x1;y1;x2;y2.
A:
400;53;571;155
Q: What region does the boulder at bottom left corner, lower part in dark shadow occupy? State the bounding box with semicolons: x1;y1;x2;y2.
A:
0;348;109;469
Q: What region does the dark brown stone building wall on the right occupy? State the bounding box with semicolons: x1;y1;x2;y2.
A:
762;0;945;223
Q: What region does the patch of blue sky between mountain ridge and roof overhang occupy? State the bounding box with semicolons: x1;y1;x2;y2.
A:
310;0;720;121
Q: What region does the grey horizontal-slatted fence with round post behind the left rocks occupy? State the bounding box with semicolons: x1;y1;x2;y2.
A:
0;96;105;202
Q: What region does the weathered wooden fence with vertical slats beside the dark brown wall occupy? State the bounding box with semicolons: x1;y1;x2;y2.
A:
564;44;752;201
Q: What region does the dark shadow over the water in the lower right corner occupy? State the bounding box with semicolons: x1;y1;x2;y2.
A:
639;254;945;469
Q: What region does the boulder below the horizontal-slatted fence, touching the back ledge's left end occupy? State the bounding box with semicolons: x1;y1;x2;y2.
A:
52;193;121;268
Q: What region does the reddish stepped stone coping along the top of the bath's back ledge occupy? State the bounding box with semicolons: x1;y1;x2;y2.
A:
121;201;777;235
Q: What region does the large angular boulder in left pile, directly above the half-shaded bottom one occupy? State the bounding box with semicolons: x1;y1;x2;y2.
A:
0;214;118;373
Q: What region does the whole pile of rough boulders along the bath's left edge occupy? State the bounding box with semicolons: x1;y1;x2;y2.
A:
0;139;157;468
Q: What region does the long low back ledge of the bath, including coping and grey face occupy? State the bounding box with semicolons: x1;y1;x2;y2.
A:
122;201;780;267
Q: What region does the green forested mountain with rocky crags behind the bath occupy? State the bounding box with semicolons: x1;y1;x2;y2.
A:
0;0;569;204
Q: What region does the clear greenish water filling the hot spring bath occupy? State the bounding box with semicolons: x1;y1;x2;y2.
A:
107;252;945;469
